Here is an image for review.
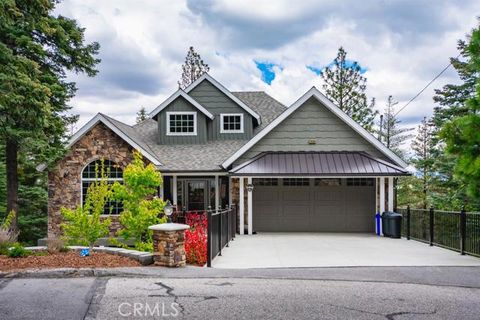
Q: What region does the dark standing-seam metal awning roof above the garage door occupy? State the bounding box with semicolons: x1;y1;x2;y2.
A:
230;152;409;177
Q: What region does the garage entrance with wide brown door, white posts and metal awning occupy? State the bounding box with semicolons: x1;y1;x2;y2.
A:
230;151;408;234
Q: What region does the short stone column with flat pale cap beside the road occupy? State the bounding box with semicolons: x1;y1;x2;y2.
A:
148;223;190;268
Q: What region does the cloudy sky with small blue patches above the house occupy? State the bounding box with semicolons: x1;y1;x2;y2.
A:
56;0;480;135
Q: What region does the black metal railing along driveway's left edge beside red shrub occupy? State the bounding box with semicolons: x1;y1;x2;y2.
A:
207;206;237;267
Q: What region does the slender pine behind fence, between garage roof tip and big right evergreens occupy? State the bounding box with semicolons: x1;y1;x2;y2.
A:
412;117;434;209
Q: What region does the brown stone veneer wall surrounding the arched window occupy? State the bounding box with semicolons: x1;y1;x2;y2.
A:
48;123;137;238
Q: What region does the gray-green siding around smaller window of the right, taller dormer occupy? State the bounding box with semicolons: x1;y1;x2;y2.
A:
188;80;253;140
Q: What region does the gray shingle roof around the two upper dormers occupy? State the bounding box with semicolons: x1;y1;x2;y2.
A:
125;92;286;171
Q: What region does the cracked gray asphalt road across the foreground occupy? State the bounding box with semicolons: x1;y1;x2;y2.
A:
0;267;480;319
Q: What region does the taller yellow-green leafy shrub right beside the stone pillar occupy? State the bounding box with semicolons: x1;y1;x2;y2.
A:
113;151;166;251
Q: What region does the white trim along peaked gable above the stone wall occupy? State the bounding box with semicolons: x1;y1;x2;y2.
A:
37;113;163;171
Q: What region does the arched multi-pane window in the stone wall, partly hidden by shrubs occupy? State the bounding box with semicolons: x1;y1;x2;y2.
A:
82;160;123;214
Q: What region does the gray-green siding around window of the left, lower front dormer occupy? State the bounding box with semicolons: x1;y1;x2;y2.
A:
157;97;210;145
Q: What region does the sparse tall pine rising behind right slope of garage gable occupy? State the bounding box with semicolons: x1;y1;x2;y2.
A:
322;47;377;131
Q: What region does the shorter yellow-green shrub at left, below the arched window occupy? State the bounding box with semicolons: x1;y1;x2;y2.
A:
60;164;112;251
